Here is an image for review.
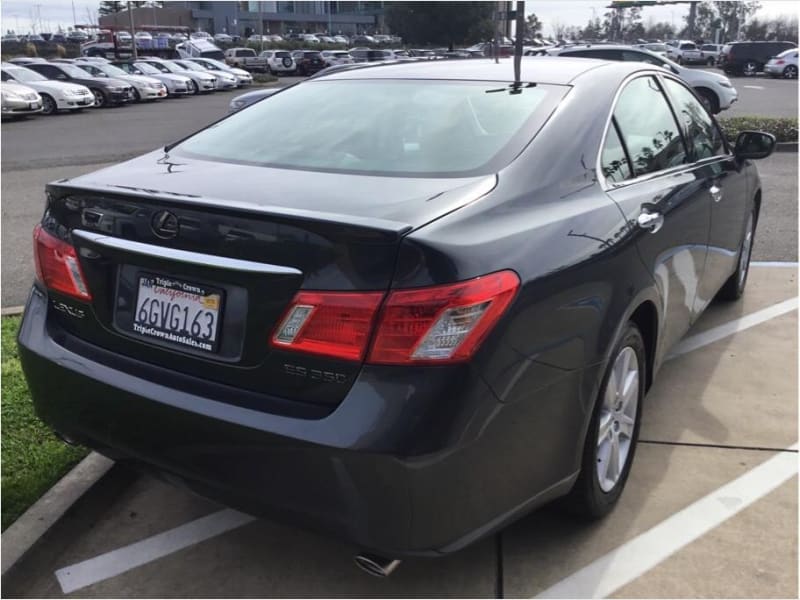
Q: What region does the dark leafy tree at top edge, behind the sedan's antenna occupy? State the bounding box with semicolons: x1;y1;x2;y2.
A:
386;2;497;49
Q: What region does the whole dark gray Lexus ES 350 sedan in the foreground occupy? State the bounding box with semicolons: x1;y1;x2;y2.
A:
19;57;774;573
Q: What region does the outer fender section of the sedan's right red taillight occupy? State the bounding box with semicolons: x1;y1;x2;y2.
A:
367;271;519;364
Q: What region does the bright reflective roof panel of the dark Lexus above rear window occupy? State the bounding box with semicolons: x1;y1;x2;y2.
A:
315;56;628;85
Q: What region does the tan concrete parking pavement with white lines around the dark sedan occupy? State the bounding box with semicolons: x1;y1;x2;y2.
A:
3;266;798;598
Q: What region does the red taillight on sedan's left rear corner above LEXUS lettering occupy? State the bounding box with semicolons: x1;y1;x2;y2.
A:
33;225;92;301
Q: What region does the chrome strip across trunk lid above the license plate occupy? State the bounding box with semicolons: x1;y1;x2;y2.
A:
72;229;303;276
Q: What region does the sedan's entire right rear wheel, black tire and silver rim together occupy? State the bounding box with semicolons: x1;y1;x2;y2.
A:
565;321;647;520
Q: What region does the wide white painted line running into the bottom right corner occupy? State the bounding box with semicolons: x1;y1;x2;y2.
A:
536;444;797;598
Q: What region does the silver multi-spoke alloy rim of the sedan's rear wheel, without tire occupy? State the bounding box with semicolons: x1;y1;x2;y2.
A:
597;346;640;493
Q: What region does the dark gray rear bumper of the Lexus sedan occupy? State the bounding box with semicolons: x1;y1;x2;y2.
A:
19;290;582;556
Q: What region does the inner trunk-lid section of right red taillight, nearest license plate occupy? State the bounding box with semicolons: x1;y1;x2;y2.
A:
272;292;383;360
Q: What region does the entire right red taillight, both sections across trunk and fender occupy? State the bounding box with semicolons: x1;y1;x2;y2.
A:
271;271;519;365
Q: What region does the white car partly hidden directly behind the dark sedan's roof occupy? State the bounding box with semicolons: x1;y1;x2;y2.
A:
548;44;739;113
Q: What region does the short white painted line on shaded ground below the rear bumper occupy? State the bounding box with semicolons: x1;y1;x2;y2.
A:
56;509;255;594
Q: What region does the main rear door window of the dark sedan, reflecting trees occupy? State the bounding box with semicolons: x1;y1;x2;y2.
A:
614;77;686;176
